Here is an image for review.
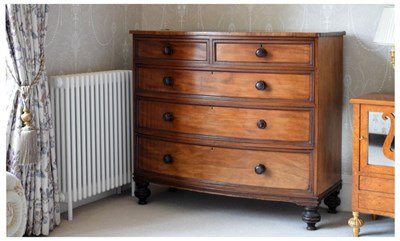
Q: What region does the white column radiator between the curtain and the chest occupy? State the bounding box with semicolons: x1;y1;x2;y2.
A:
49;70;132;220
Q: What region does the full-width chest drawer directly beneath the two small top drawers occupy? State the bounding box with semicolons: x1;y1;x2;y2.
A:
138;68;313;101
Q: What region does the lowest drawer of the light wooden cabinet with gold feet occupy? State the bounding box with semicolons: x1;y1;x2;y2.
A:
358;193;394;214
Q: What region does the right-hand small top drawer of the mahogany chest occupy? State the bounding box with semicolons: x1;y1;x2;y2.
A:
215;41;313;65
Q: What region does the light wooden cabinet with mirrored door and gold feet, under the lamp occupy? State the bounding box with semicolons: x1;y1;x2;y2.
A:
348;93;395;237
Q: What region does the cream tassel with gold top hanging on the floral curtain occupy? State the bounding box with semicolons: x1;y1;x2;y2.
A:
15;107;39;165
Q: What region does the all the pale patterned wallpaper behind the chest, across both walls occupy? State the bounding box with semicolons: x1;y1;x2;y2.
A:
46;4;394;175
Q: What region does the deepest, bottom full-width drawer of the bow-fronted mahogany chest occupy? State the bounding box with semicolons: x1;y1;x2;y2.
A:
138;137;310;190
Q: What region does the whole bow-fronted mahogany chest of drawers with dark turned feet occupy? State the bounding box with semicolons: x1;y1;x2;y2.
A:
130;31;345;230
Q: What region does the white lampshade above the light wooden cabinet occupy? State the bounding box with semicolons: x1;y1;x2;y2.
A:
374;6;395;45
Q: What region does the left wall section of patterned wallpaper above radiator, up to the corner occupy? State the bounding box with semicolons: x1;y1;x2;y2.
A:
46;4;141;75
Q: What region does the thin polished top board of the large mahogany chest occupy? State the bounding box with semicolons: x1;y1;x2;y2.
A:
129;29;346;37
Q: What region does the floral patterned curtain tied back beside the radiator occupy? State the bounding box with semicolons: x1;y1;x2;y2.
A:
6;4;60;236
